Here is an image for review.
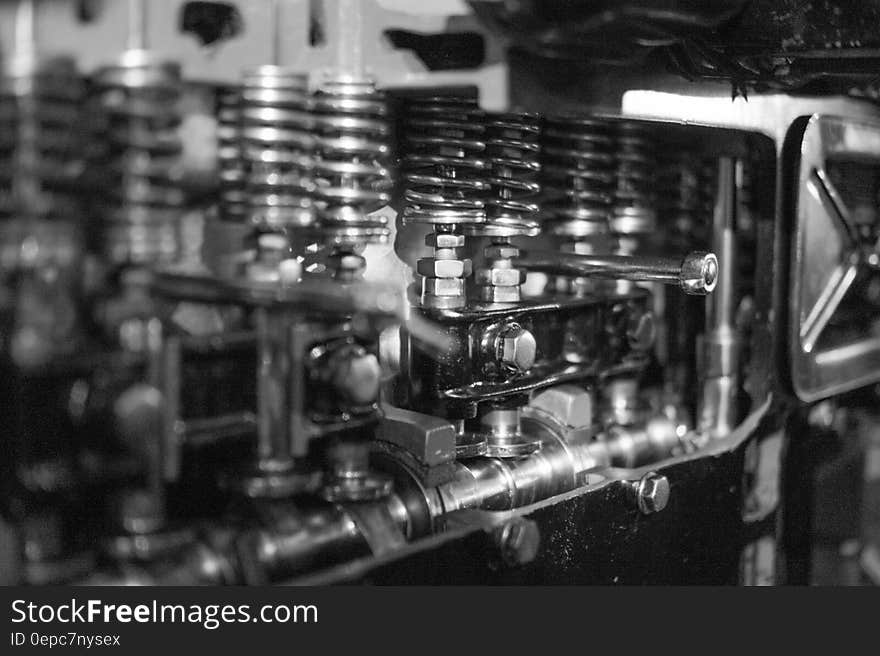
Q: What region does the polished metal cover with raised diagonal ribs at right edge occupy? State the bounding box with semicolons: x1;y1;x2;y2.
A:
789;115;880;401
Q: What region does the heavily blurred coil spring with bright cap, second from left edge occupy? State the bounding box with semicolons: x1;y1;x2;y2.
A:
90;50;184;265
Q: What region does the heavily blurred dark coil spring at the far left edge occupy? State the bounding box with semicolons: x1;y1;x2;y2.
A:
0;57;85;219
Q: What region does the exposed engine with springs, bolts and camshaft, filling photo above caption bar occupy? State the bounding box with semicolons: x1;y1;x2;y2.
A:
0;0;880;585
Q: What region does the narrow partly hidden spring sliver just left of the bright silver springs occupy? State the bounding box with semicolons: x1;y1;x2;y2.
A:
217;87;247;223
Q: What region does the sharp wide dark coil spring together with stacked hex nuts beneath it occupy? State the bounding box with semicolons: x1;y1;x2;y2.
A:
403;96;490;309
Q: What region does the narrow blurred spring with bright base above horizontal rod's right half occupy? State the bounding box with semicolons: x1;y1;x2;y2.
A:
611;121;657;255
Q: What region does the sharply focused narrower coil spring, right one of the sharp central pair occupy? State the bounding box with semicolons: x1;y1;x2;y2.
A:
473;113;541;237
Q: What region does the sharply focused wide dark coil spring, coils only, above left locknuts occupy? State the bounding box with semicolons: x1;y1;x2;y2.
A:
403;96;490;225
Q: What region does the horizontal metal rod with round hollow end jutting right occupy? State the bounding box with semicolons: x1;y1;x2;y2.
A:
514;251;718;296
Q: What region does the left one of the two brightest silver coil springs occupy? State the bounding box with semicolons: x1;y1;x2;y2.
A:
239;66;315;230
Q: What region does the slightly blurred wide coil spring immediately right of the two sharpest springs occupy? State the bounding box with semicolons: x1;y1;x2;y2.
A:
541;117;616;239
